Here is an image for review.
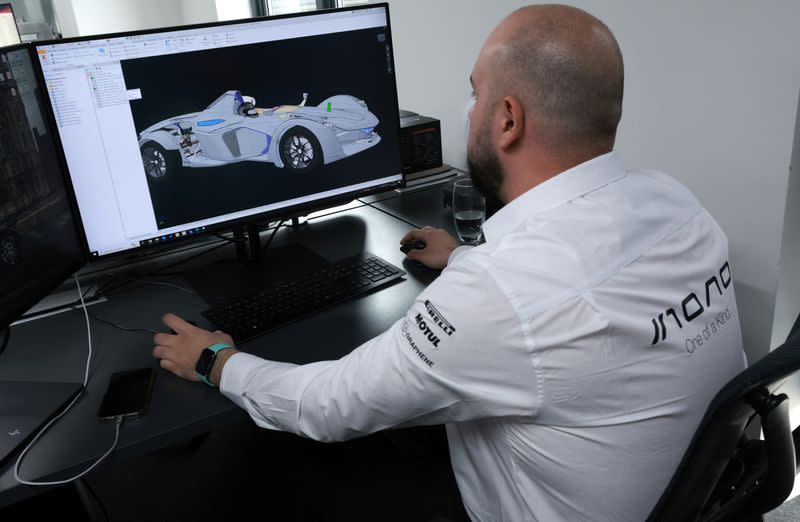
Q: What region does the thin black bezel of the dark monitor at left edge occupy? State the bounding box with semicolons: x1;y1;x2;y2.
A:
0;43;90;331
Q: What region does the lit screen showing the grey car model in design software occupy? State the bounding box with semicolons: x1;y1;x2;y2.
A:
37;5;403;256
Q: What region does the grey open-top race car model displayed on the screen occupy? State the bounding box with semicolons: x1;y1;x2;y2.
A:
139;91;381;179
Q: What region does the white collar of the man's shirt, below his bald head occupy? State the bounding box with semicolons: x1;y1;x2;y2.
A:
483;151;625;241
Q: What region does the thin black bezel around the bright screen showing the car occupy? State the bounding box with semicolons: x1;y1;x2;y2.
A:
33;2;406;262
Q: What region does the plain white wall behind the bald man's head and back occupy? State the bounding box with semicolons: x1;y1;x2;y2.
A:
382;0;800;361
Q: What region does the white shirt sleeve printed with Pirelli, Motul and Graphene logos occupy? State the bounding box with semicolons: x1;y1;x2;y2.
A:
220;253;538;441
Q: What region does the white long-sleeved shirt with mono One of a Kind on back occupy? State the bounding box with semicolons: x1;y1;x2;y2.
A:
221;153;745;522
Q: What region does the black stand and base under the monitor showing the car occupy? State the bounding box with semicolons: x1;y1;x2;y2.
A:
184;220;330;306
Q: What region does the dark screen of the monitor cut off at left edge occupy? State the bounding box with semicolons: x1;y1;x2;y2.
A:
0;47;85;329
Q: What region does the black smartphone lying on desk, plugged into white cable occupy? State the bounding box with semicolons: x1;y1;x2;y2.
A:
98;368;156;420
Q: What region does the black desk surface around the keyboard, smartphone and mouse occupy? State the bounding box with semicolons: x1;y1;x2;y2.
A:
0;199;444;507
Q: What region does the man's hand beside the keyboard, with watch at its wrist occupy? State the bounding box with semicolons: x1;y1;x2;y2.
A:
153;314;233;384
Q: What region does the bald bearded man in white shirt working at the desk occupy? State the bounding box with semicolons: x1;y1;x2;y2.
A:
154;5;744;521
